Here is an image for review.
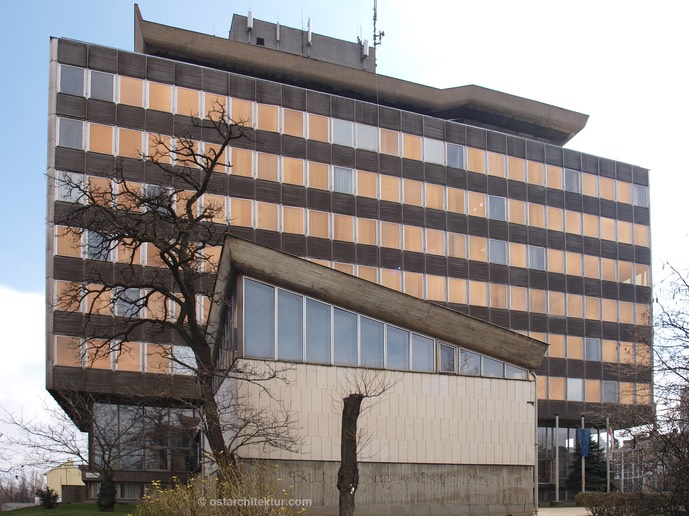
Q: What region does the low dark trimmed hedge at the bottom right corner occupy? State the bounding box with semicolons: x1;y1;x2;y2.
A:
576;493;672;516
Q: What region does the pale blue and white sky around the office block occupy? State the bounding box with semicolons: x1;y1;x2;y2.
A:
0;0;689;466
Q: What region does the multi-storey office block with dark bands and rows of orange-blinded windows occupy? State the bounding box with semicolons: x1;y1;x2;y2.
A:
47;4;652;504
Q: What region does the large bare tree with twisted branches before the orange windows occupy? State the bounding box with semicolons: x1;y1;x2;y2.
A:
52;103;299;482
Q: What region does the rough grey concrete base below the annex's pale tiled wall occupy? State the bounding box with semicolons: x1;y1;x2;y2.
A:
270;461;534;516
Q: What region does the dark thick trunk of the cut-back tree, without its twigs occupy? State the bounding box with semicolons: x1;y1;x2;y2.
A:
337;394;364;516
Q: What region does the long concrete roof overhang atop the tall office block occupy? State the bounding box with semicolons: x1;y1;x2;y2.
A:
134;6;588;145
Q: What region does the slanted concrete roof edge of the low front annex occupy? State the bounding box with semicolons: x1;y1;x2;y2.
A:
208;236;547;370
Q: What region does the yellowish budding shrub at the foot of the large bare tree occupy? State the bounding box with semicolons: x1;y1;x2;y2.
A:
135;463;305;516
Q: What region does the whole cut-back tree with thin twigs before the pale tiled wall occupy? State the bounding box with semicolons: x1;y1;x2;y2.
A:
337;368;398;516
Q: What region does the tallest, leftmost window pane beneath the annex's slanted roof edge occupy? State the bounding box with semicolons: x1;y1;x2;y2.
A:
244;279;275;358
